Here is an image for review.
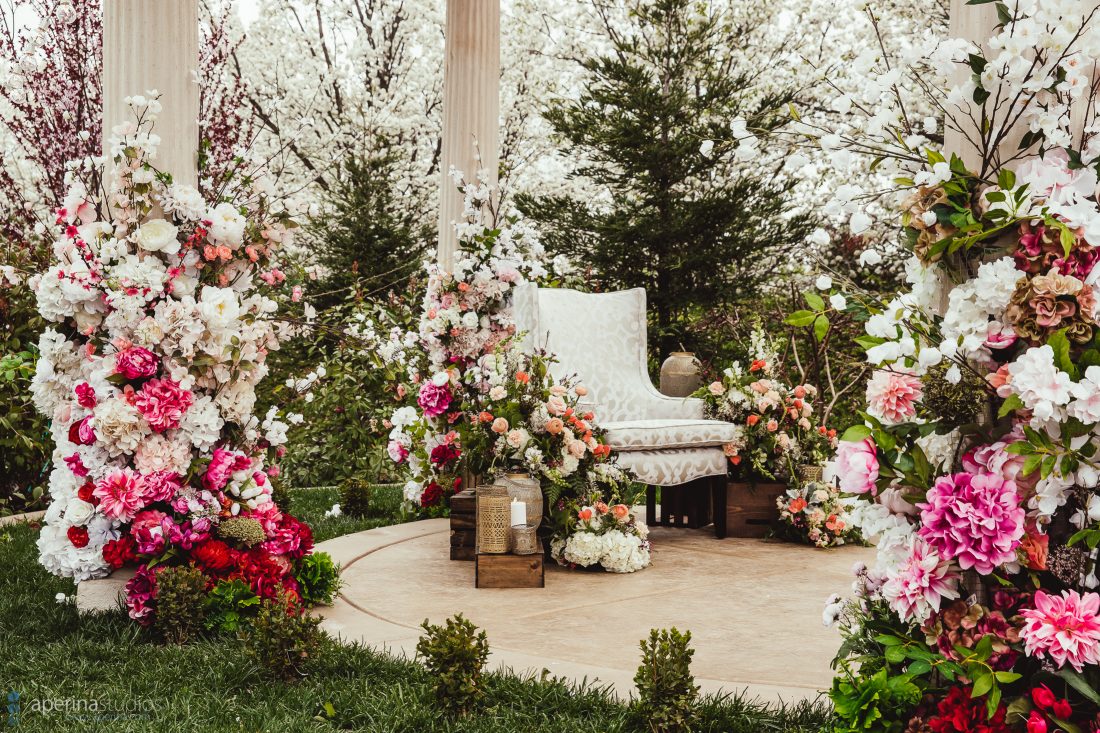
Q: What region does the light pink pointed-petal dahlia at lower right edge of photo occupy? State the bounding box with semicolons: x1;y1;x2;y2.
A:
1020;590;1100;671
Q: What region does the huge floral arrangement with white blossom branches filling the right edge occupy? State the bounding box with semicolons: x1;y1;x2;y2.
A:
826;2;1100;733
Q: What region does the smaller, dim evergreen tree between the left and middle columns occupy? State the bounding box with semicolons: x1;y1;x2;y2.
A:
310;149;435;309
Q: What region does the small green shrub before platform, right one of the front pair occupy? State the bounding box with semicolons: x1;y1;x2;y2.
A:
631;628;699;733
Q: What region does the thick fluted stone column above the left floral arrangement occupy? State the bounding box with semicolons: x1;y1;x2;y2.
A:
102;0;199;186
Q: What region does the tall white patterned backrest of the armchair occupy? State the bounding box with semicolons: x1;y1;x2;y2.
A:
514;284;653;423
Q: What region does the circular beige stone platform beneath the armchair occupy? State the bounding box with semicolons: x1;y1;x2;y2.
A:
318;519;873;701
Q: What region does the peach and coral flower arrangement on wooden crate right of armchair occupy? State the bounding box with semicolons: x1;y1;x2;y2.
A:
692;328;837;480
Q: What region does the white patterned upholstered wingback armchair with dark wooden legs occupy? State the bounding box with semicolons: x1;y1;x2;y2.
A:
514;284;735;537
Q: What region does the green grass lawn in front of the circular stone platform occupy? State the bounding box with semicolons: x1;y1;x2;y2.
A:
0;490;827;733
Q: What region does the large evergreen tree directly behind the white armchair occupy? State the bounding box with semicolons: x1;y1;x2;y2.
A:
517;0;812;355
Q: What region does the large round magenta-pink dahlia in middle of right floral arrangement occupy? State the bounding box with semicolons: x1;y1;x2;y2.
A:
917;473;1025;576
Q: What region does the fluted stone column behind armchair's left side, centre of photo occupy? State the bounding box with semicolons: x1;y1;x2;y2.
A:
437;0;501;269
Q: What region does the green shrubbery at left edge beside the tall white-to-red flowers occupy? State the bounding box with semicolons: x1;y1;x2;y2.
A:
0;240;53;516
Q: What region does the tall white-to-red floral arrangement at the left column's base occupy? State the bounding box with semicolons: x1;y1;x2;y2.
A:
24;92;325;623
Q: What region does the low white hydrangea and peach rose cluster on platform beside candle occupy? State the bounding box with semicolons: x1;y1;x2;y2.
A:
550;492;650;572
